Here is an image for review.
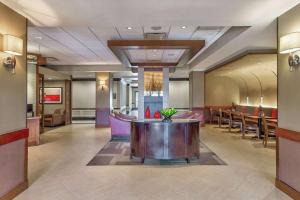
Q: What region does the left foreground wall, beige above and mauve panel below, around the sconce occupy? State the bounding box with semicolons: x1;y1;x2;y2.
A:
0;3;27;198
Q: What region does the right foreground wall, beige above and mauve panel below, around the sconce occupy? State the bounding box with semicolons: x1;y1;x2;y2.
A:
277;5;300;196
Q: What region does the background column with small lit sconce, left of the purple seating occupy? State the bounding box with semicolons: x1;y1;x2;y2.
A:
96;72;112;127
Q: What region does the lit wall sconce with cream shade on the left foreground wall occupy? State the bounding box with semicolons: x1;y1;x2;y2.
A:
0;34;23;74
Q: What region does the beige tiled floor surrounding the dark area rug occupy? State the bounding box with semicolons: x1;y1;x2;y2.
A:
17;124;289;200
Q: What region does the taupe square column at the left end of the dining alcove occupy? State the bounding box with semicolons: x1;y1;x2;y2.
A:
189;71;205;125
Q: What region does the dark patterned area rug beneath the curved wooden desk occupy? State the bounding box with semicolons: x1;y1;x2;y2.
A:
87;141;226;166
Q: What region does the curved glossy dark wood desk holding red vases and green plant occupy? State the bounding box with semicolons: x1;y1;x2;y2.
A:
130;119;200;163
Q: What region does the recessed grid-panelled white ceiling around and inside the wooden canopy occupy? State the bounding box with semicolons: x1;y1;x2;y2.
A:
28;26;225;65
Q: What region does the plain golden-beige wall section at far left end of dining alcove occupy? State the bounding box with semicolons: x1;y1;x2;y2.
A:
205;75;240;106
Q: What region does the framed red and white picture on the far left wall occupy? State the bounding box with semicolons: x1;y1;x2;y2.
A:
40;87;63;104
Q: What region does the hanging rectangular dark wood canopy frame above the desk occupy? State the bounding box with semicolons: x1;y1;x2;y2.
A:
107;40;205;68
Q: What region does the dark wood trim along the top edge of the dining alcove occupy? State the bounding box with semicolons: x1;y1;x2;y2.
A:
205;49;277;73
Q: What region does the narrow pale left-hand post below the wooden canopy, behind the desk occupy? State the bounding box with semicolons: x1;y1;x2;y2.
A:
138;68;145;120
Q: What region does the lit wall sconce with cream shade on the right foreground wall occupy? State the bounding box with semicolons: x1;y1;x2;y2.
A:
279;32;300;71
